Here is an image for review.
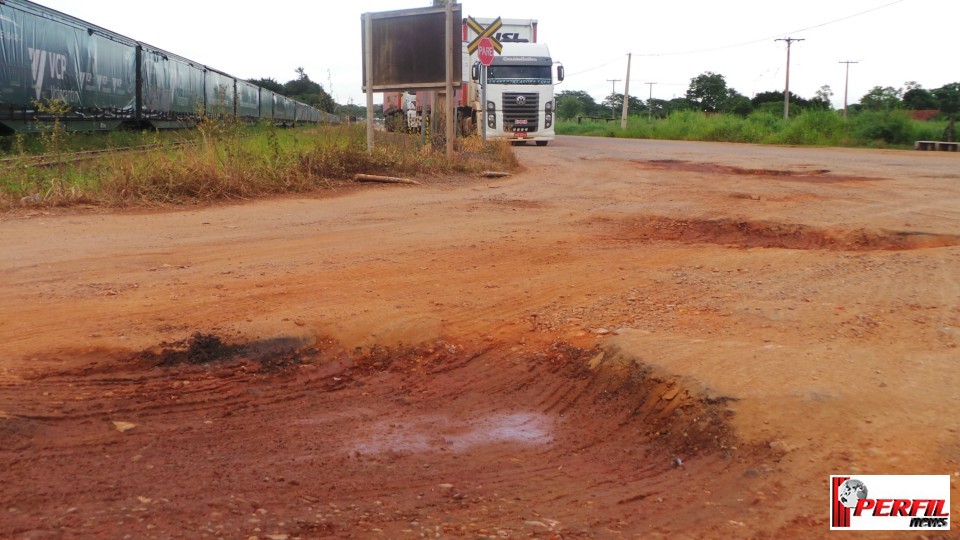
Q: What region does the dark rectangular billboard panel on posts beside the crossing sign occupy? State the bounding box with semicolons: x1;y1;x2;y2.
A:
361;4;463;92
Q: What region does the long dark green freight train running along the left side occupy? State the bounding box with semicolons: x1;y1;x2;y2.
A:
0;0;339;134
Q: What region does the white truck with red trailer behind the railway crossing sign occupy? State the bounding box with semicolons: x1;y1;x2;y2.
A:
383;18;564;146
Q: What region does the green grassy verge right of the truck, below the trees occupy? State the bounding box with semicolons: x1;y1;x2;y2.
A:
557;111;947;148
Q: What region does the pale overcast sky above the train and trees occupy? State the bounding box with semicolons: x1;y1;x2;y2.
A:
33;0;960;107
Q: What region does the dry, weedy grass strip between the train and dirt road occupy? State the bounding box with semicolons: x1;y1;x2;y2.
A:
0;122;517;208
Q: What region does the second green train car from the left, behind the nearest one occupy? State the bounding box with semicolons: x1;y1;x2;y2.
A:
137;43;205;129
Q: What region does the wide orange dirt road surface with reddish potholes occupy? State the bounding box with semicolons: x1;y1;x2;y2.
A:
0;137;960;539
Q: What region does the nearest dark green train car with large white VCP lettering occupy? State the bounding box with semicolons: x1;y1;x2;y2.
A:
0;0;138;131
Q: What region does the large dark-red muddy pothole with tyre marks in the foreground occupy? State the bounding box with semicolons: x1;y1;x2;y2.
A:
0;340;771;537
